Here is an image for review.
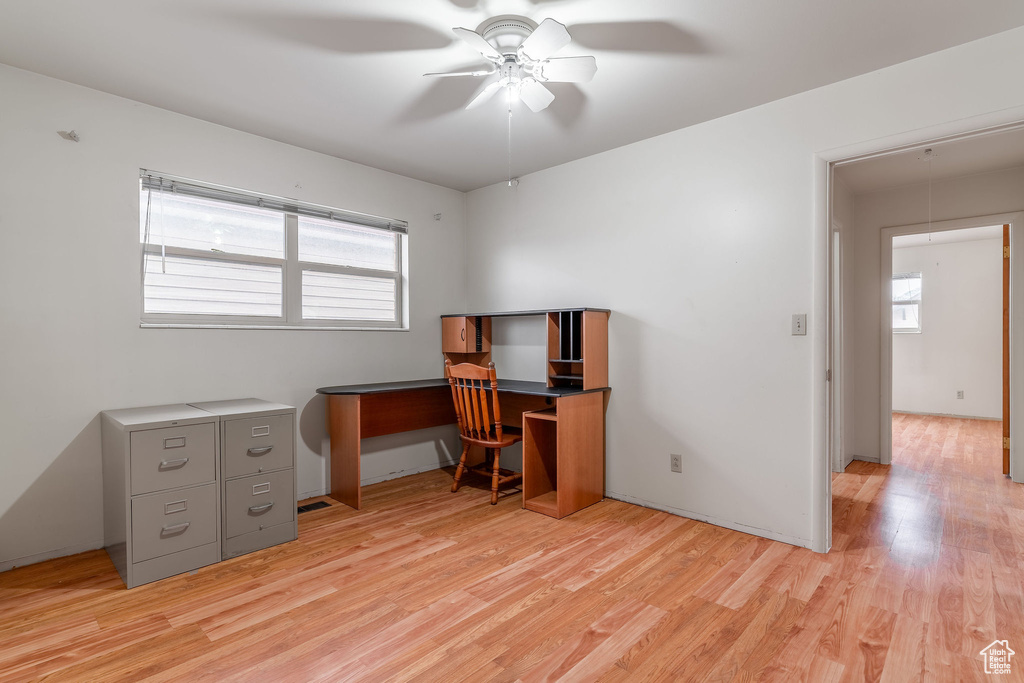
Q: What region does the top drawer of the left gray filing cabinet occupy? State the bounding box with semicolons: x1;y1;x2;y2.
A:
131;422;217;496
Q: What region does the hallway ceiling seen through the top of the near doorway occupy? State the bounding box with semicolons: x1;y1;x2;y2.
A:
836;127;1024;195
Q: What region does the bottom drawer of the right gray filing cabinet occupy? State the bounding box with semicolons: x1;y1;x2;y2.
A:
224;470;295;539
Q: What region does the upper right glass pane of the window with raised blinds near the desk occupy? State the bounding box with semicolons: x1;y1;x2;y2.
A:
299;216;398;272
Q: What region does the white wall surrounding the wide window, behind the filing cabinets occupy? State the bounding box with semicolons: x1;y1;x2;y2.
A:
0;66;465;569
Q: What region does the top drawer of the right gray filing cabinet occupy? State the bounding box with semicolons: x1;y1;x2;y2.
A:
224;415;295;479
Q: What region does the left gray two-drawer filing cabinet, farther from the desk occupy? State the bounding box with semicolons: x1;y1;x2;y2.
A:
100;403;220;588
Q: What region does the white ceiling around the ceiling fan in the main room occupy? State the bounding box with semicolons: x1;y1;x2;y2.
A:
6;0;1024;190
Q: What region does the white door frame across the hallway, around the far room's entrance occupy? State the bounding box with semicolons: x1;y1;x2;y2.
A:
879;211;1024;482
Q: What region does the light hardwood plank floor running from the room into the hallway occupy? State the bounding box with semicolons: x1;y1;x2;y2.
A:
0;416;1024;683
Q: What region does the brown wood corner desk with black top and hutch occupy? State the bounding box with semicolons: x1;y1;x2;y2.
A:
316;308;610;518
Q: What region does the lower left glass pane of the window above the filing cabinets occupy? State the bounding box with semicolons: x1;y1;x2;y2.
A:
143;255;283;317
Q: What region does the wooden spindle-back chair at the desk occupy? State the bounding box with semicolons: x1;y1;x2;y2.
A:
444;360;522;505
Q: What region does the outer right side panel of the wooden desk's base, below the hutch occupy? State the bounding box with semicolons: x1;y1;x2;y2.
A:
558;392;604;518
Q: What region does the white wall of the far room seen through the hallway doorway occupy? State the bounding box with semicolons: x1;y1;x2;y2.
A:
892;240;1002;420
